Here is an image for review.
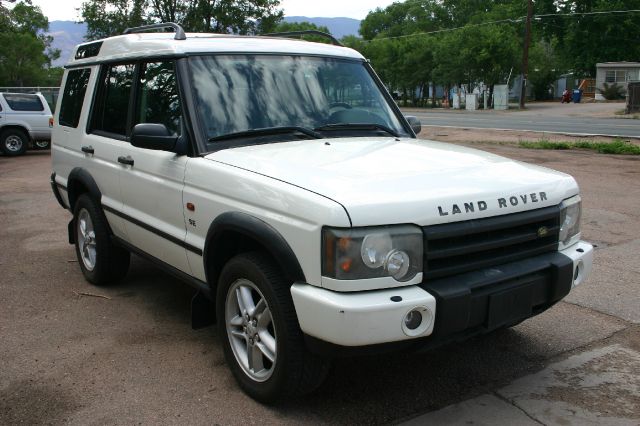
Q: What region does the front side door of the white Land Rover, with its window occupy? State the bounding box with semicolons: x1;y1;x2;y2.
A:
120;60;191;273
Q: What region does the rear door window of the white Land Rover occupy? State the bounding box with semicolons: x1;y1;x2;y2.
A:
90;64;135;136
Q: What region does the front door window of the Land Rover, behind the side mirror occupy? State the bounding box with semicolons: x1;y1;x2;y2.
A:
133;61;182;135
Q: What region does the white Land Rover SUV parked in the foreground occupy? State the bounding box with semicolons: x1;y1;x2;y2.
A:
51;24;593;401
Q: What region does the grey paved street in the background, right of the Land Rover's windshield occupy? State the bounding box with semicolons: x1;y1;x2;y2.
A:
408;104;640;138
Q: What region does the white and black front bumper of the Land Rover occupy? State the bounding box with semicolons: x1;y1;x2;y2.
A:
291;241;593;355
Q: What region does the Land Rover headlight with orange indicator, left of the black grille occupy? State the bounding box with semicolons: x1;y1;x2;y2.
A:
322;225;423;281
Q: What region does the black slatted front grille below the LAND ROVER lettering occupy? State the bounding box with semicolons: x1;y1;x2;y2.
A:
423;206;560;279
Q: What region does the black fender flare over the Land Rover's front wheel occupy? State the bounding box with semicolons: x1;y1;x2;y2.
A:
203;212;306;287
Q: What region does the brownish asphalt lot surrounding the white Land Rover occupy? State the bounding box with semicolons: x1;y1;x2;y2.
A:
0;146;640;425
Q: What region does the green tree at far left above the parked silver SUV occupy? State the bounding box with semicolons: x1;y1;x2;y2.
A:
0;0;60;86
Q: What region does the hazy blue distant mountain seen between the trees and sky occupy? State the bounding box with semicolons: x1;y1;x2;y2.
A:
49;16;360;67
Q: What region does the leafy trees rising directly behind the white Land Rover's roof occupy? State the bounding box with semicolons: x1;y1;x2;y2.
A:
81;0;283;40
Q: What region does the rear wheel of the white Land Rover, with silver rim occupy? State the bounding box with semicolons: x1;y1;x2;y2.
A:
73;194;130;285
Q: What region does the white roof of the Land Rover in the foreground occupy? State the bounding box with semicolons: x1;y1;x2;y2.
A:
67;32;364;66
